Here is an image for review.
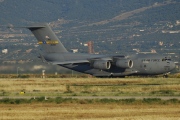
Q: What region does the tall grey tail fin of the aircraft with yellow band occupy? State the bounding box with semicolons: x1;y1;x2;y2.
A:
26;23;68;53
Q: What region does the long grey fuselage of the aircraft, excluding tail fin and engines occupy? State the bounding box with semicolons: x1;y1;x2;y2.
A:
44;53;175;77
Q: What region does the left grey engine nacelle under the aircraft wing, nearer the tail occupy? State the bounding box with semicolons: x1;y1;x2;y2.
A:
91;60;111;70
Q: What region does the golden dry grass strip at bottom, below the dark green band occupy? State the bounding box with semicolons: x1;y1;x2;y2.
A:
0;103;180;120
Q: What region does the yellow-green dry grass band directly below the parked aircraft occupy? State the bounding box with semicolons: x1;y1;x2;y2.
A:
0;78;180;97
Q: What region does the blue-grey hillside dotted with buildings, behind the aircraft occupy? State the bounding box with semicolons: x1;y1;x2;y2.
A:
0;0;180;73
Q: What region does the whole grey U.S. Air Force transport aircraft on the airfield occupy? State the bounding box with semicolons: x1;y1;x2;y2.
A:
25;23;175;77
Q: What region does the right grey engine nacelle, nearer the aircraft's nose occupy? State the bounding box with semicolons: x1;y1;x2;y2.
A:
116;59;133;68
